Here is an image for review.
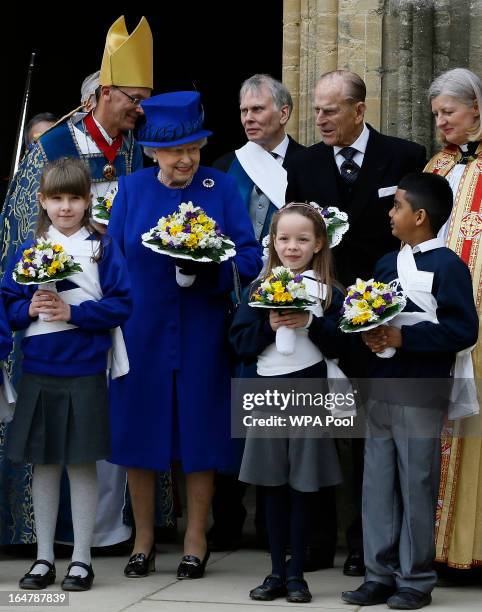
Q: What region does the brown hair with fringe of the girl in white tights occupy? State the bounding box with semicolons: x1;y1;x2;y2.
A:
35;157;102;261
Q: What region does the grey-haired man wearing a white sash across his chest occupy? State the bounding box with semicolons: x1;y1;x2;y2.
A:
209;74;304;550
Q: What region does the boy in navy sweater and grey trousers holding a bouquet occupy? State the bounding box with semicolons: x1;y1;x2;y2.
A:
342;173;478;610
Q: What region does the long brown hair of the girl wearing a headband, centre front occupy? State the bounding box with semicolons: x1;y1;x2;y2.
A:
263;202;340;309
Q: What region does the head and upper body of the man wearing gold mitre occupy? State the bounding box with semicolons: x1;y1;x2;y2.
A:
0;16;153;256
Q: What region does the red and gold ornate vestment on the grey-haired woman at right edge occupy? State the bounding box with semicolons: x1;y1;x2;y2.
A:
425;144;482;569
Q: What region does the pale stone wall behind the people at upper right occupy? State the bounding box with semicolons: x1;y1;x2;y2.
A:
283;0;482;150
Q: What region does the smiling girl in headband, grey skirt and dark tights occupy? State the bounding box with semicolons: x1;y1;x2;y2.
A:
230;203;343;603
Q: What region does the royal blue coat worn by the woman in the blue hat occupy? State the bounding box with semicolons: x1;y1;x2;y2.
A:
109;167;261;473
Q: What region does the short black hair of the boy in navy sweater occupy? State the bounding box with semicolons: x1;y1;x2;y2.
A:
398;172;454;235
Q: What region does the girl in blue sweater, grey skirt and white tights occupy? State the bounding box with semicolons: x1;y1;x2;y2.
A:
2;158;131;591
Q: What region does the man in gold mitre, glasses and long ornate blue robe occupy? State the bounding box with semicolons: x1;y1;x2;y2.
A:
0;16;153;546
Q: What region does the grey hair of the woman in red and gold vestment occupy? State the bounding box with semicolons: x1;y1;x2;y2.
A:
428;68;482;141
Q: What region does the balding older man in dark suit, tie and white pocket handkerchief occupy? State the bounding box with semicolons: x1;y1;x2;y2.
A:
286;70;426;576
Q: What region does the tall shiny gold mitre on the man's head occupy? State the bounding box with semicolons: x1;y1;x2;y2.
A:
99;15;153;89
